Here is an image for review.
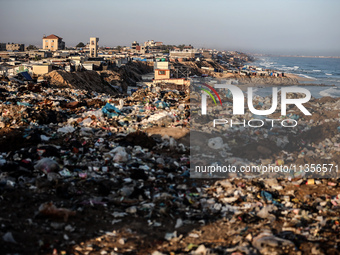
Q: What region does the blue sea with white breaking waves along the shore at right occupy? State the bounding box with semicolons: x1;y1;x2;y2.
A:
251;57;340;98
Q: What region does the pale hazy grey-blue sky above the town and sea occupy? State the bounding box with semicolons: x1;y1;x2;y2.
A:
0;0;340;56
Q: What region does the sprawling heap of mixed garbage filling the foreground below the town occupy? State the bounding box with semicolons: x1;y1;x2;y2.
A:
0;78;340;255
